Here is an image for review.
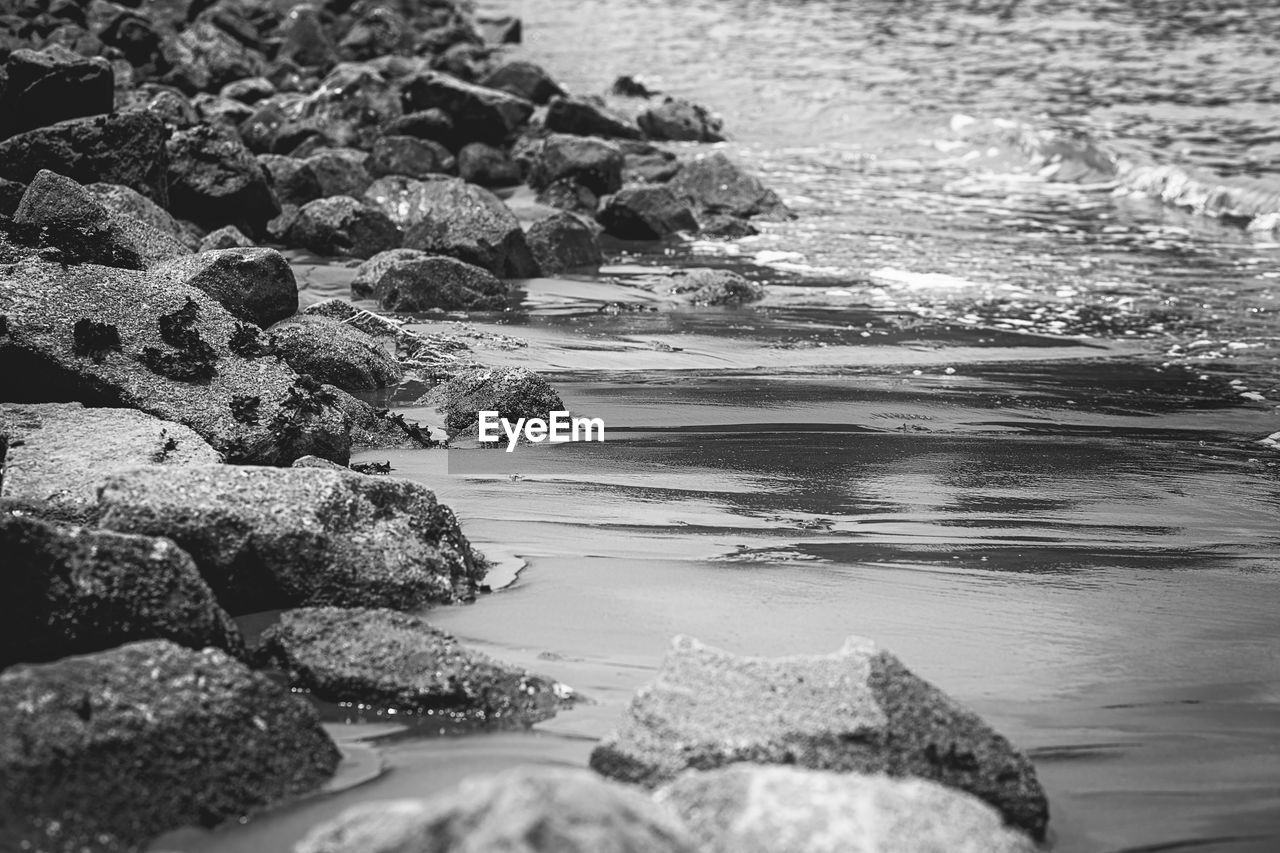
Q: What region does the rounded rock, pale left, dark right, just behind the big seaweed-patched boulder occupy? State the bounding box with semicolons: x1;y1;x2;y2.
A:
148;248;298;328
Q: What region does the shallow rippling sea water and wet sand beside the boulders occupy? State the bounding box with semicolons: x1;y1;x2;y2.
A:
157;0;1280;853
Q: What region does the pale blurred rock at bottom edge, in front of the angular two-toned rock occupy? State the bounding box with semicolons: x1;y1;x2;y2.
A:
655;763;1037;853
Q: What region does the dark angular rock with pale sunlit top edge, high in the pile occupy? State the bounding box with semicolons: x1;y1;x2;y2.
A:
403;72;534;145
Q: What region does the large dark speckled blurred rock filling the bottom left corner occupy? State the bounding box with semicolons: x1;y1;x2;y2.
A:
0;640;340;850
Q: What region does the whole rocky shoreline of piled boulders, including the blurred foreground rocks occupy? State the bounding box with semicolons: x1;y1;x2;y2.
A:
0;0;1048;853
